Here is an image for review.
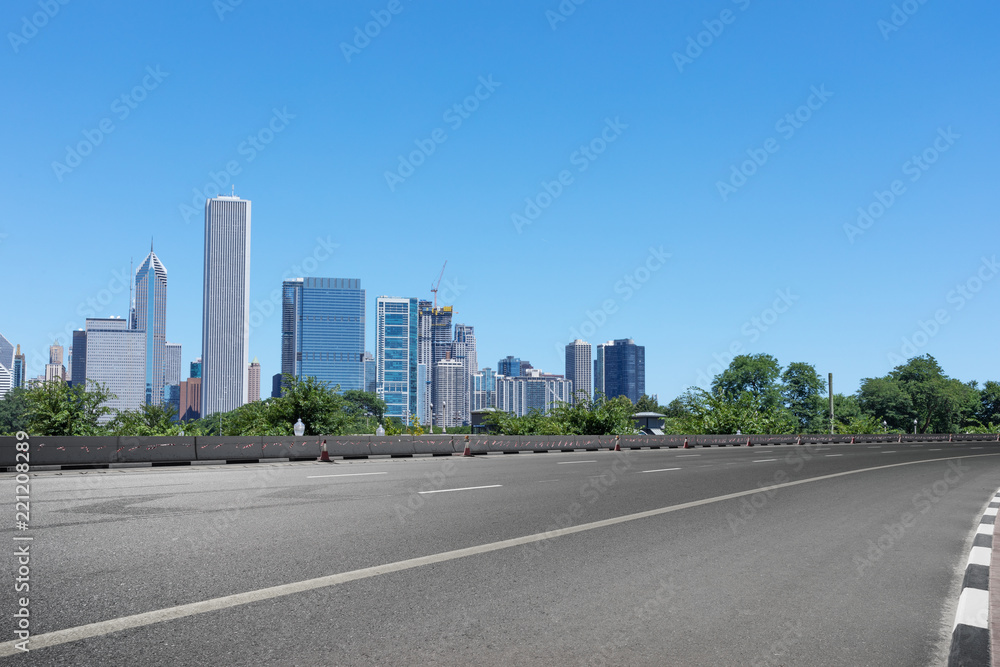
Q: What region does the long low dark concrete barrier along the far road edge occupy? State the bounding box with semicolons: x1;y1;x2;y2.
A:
0;434;1000;469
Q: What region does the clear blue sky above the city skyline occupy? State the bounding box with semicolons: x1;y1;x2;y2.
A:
0;0;1000;402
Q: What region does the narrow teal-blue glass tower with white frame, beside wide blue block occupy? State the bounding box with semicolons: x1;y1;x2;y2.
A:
375;296;418;424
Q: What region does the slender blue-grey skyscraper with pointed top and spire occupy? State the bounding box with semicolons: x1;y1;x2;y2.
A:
133;244;167;405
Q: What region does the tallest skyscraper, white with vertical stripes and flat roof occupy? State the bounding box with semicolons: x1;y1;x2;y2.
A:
201;197;250;417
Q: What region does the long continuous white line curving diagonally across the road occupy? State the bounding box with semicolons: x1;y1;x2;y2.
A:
9;454;1000;657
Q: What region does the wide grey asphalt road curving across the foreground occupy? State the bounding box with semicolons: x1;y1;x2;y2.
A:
0;443;1000;667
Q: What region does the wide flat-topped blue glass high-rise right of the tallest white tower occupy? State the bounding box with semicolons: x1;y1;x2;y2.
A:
281;278;365;391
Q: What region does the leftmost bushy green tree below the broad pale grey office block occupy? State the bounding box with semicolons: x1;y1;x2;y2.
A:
24;380;115;436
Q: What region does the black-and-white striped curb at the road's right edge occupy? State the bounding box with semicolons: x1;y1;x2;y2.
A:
948;490;1000;667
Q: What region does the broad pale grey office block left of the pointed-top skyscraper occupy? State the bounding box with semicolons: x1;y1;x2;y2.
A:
77;317;146;422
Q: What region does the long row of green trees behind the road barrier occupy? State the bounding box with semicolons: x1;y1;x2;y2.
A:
0;354;1000;436
